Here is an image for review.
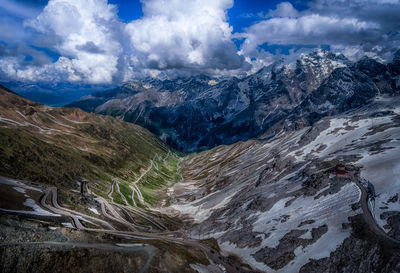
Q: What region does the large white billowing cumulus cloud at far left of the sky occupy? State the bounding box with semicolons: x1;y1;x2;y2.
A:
0;0;123;83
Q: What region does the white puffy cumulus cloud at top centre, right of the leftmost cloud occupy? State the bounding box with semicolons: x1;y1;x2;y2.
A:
126;0;243;70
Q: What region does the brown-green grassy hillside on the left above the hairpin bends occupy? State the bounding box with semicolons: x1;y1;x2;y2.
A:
0;87;178;203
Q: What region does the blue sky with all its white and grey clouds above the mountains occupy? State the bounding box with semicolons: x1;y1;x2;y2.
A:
0;0;400;84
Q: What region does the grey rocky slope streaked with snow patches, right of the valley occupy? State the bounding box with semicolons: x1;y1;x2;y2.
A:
166;94;400;272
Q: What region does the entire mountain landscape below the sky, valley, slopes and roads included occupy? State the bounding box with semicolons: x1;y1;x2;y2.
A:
0;50;400;272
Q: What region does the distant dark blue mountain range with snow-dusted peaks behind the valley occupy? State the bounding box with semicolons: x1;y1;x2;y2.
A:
67;50;400;151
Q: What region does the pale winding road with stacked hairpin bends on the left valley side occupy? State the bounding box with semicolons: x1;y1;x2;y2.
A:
0;152;250;273
